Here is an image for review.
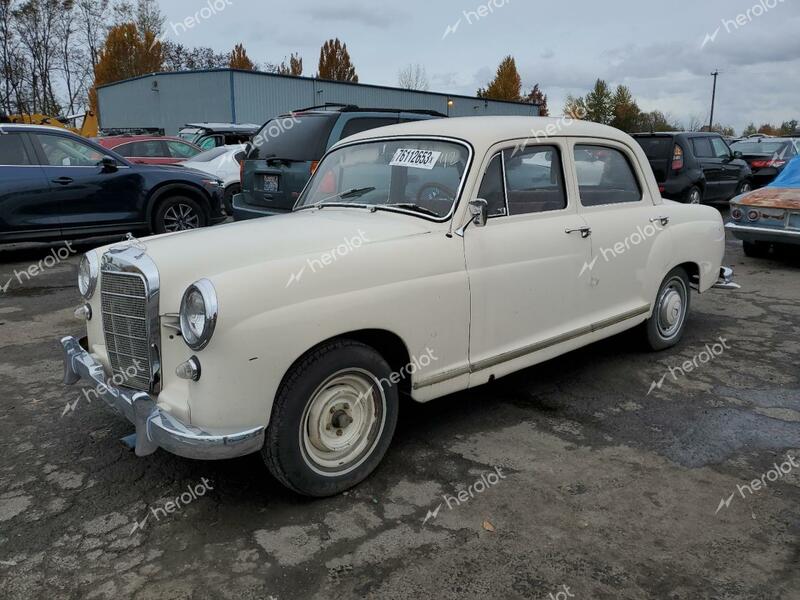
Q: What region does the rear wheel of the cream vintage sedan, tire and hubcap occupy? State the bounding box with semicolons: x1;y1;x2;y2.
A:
643;267;692;352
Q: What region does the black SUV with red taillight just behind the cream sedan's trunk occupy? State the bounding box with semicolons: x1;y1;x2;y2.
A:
633;131;753;204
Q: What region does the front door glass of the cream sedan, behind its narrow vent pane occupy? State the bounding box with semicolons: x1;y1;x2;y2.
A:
504;146;567;215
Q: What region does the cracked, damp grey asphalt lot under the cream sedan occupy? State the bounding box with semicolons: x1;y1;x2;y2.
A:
0;217;800;600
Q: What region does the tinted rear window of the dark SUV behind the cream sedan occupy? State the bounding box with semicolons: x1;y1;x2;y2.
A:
247;113;339;162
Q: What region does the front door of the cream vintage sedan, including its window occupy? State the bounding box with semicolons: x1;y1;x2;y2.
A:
464;141;591;385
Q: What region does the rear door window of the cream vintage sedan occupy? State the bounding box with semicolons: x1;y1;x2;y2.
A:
575;144;642;206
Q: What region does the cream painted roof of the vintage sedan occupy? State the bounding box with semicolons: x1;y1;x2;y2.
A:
340;117;630;147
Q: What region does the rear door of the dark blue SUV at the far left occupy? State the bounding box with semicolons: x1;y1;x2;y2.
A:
0;128;61;241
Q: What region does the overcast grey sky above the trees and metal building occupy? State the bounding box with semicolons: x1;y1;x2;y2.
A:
161;0;800;131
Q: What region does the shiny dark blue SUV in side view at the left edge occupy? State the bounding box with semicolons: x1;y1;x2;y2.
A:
0;125;225;242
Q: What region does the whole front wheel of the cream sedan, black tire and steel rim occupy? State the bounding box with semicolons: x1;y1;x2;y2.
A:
261;339;399;498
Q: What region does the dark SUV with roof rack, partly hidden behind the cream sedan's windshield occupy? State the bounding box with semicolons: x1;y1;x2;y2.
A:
233;104;445;221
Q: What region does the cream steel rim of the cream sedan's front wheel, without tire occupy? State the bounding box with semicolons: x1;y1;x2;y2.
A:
300;369;386;476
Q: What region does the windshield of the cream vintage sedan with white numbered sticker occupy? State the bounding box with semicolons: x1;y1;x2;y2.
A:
295;139;470;219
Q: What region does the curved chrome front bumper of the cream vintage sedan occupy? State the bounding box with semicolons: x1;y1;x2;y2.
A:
61;336;265;460
